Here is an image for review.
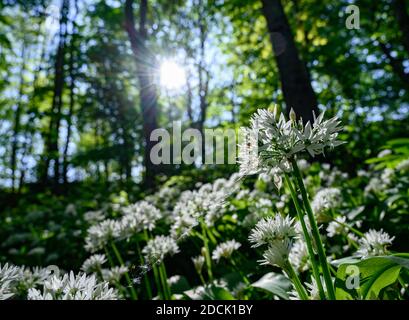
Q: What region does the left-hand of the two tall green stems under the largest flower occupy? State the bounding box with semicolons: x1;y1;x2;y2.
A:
284;173;326;300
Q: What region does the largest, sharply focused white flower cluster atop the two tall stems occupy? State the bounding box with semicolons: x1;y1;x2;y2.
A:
238;106;342;175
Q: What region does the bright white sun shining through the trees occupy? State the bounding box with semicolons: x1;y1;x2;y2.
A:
159;60;186;91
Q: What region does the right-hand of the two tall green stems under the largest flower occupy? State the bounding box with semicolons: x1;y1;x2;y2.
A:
291;159;336;300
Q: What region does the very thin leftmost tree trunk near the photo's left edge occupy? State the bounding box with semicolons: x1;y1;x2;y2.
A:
10;39;26;193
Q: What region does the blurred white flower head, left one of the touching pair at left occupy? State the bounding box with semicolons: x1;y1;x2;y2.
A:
85;219;121;252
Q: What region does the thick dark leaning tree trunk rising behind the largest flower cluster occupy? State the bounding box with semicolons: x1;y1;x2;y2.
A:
261;0;317;122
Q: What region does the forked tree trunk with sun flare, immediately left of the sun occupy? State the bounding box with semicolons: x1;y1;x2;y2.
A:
125;0;160;187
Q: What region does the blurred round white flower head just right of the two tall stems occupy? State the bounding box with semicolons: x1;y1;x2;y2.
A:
311;188;342;222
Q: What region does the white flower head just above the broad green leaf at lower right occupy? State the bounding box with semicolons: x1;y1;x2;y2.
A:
356;229;395;258
